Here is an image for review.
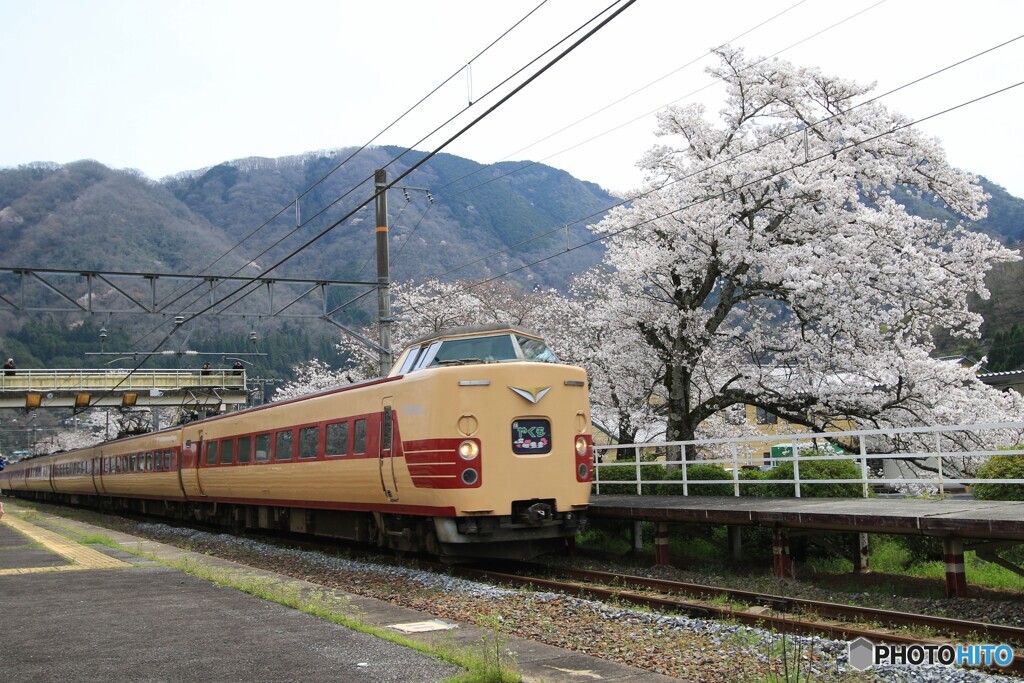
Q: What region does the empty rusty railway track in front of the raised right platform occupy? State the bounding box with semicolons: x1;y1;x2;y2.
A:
447;563;1024;675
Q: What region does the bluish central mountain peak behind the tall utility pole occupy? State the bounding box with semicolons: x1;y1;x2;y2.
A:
163;146;615;288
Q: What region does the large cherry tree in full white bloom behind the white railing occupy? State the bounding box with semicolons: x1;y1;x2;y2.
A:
596;48;1020;454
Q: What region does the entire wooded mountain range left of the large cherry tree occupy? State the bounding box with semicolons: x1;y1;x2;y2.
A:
0;147;616;376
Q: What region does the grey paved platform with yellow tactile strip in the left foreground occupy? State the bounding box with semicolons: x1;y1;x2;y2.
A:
0;499;673;683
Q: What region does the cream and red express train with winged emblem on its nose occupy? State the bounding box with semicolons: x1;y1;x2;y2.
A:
0;327;593;559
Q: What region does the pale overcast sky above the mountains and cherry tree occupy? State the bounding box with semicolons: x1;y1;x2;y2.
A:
0;0;1024;197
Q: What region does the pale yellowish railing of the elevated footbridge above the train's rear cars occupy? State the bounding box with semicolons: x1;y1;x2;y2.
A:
0;368;246;392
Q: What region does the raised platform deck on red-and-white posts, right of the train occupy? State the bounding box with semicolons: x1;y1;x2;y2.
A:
587;496;1024;597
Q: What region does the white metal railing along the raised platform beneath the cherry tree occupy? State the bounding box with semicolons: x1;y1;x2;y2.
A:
594;422;1024;498
